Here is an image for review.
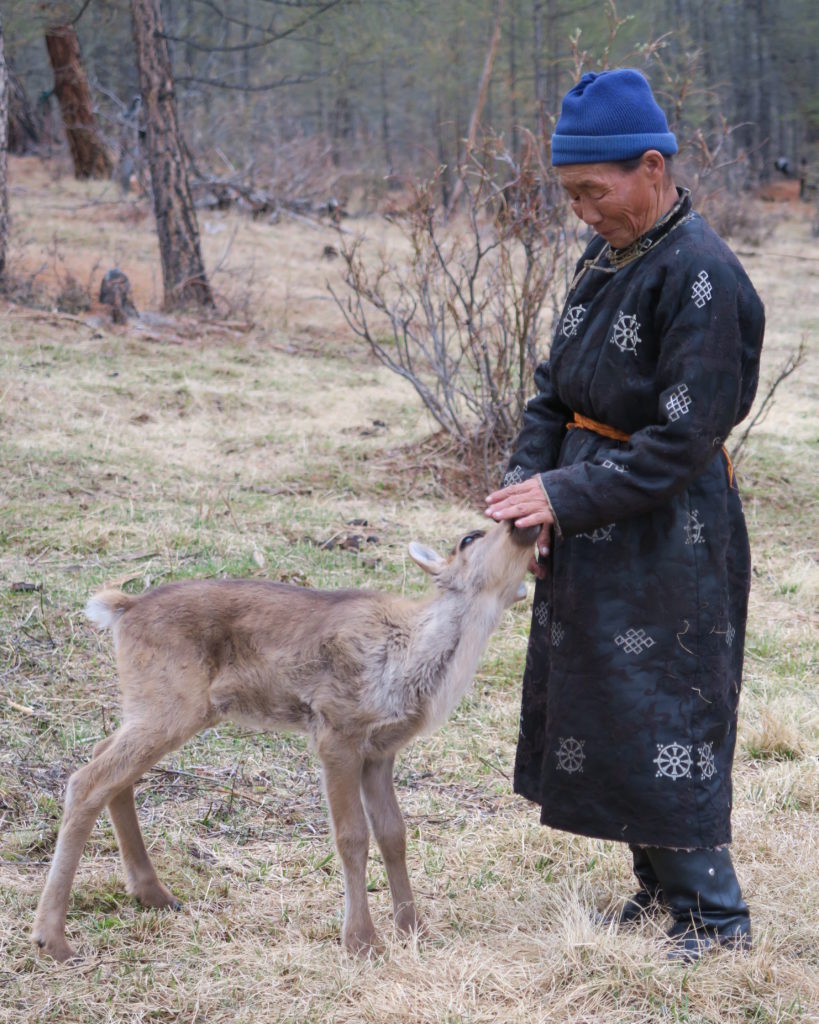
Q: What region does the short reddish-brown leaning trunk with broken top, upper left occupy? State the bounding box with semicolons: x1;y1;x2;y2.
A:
45;25;114;178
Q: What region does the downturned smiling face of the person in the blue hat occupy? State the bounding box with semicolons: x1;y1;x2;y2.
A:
558;154;663;249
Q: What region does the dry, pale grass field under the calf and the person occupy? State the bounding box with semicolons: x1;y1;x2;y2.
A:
0;155;819;1024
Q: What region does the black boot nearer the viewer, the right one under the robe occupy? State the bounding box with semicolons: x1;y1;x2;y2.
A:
646;847;751;961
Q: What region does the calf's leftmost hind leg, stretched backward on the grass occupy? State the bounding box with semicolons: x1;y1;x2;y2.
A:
33;723;184;961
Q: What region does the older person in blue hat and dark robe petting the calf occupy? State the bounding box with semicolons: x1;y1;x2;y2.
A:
486;69;764;959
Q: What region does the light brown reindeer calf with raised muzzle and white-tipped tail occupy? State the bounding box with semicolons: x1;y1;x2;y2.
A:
34;524;538;961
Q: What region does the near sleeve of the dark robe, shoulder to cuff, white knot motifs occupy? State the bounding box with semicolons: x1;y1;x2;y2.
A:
542;254;764;534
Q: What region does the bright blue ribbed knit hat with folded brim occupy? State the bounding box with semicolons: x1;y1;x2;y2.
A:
552;68;677;167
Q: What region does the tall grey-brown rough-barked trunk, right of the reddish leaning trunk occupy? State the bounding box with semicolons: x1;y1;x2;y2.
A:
131;0;213;309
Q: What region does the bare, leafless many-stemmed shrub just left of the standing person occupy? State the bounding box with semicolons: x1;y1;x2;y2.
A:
331;136;565;487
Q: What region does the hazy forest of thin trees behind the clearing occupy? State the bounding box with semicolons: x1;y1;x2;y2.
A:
2;0;819;197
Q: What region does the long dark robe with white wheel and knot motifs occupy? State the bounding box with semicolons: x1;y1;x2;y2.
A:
504;195;764;848
